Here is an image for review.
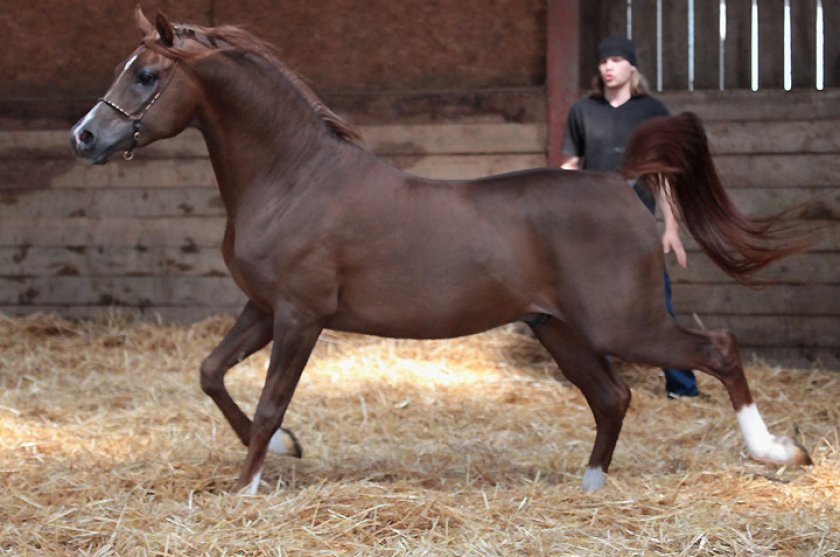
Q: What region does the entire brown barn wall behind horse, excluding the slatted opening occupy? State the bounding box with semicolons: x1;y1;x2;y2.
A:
0;0;840;364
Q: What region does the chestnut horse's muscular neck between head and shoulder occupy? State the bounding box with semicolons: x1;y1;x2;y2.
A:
194;54;341;216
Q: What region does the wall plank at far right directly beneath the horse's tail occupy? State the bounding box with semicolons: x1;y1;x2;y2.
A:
673;284;840;314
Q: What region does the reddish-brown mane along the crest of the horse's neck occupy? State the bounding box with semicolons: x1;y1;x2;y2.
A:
143;24;362;143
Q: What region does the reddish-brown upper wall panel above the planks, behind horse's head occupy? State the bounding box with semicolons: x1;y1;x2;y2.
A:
0;0;544;124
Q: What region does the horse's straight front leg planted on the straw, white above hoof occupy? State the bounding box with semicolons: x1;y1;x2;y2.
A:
236;317;321;495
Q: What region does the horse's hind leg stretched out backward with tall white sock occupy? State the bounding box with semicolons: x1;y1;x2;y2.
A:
617;324;811;465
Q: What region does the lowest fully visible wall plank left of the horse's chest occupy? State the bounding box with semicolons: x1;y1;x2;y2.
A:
0;276;245;307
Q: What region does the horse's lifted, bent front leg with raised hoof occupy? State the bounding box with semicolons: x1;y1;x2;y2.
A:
201;301;301;457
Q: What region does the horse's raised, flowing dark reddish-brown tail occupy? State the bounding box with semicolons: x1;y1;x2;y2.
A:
620;112;815;285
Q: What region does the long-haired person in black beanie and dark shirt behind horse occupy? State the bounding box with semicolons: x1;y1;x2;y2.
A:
561;37;699;398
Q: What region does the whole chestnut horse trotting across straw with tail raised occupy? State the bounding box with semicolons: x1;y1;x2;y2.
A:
70;9;809;493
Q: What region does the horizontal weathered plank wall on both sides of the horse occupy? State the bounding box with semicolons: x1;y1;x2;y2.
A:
0;91;840;363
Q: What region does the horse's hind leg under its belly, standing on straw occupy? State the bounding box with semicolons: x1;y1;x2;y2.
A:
533;319;630;492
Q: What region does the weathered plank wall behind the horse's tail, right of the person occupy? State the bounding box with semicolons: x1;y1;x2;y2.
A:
661;90;840;367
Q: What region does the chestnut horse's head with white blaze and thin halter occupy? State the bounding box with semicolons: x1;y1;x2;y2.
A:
70;7;198;164
